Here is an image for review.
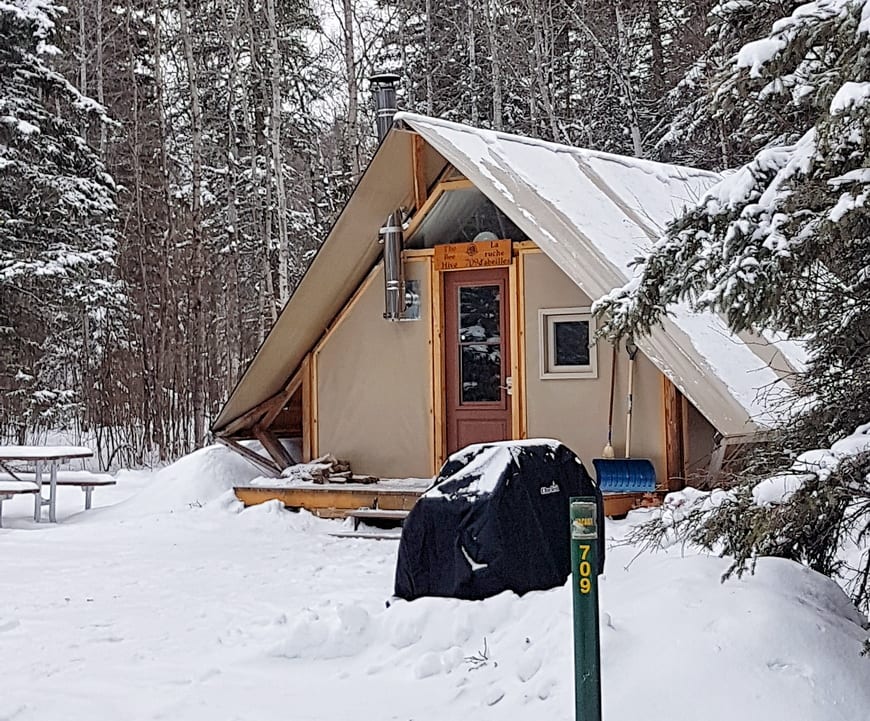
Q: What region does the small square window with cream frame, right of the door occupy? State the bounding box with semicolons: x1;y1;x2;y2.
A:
538;308;598;378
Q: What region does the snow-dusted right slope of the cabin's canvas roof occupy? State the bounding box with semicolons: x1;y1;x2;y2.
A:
396;113;798;435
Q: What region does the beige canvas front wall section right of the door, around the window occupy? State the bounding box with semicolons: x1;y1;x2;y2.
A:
523;253;665;482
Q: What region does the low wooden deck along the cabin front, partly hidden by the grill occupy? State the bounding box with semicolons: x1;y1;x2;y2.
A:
234;483;662;518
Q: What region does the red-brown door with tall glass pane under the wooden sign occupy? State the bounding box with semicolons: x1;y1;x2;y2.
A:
444;268;511;454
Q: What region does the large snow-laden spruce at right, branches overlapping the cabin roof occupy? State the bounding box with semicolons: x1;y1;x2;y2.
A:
596;0;870;603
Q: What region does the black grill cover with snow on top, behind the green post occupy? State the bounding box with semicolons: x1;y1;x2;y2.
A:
395;440;604;600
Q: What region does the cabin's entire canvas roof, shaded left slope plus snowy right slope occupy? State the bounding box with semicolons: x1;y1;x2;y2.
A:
213;113;801;436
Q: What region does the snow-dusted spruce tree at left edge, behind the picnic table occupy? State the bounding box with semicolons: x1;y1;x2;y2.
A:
0;0;123;435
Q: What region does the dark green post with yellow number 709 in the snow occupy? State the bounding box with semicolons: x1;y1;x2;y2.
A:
571;497;601;721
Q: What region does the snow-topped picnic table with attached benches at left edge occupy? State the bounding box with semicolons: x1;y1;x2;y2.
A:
0;446;115;525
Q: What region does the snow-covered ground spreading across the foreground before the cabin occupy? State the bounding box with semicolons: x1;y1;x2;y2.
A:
0;448;870;721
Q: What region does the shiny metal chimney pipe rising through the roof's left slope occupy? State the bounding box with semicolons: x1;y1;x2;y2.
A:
369;73;405;320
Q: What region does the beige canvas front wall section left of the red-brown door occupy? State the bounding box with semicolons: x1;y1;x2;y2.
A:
316;258;433;478
